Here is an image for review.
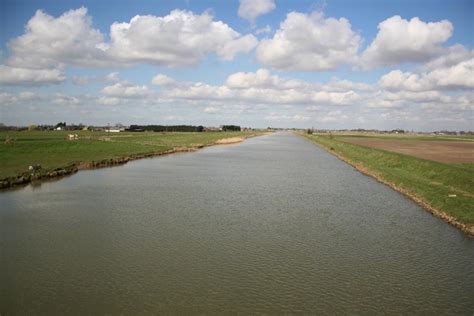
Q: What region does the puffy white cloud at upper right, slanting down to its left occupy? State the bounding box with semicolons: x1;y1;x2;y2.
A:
359;15;453;69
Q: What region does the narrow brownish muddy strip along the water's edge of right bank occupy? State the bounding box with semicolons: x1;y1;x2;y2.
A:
305;137;474;237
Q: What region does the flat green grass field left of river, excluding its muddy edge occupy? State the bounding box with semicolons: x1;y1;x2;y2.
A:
0;131;259;179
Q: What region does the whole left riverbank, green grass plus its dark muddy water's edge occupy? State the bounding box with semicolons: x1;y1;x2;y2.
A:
0;132;263;190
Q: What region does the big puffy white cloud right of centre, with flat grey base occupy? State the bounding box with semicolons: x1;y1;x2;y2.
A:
257;12;361;71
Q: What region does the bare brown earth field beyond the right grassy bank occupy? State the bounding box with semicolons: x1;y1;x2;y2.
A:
342;137;474;163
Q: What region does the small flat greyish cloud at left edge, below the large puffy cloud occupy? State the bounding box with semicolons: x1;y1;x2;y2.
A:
0;65;66;85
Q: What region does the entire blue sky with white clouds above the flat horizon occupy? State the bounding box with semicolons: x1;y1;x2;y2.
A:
0;0;474;131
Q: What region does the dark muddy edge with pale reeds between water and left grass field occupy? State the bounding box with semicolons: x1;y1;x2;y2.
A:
0;135;258;190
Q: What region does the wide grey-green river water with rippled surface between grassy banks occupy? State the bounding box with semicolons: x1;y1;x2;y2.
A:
0;133;474;315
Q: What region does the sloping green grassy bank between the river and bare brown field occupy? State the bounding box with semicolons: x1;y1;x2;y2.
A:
305;135;474;235
